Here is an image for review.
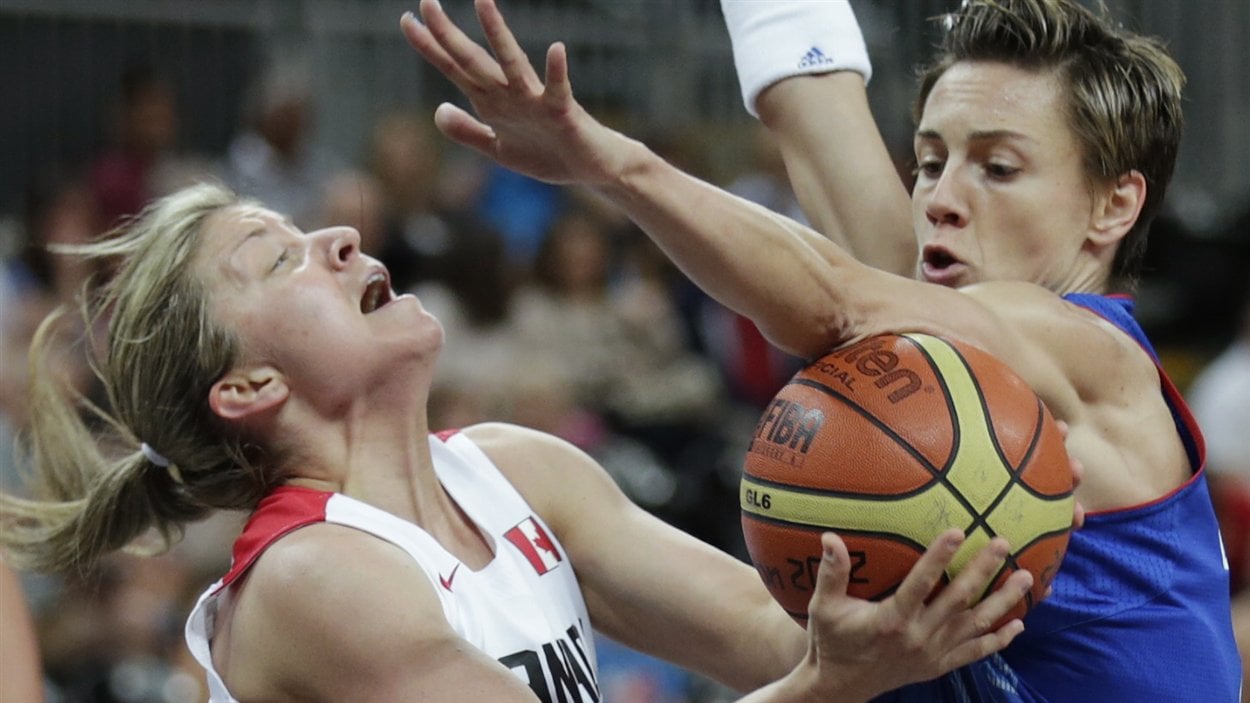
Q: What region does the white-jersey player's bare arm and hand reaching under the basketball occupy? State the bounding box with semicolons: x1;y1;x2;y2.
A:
465;424;1031;702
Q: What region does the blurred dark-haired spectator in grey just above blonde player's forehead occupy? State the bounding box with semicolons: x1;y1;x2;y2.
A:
225;60;340;225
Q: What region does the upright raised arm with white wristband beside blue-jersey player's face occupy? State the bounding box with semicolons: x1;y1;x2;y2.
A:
721;0;916;276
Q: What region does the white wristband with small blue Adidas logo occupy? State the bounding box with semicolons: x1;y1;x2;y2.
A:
720;0;873;116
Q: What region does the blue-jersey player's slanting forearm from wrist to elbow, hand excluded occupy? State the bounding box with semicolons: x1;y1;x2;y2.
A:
596;136;856;357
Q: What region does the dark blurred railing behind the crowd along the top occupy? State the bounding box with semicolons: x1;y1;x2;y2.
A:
0;0;1250;232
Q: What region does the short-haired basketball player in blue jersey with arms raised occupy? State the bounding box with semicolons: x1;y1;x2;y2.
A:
403;0;1241;703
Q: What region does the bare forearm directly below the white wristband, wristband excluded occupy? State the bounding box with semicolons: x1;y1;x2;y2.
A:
755;71;916;276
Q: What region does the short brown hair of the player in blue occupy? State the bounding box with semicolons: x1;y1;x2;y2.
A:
914;0;1185;288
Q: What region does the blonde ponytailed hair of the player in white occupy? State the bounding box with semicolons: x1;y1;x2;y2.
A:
0;184;273;572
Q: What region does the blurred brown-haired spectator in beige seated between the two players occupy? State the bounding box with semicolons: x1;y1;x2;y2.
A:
516;206;724;525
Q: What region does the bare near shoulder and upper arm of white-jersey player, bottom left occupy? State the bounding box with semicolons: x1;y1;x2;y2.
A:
221;512;552;703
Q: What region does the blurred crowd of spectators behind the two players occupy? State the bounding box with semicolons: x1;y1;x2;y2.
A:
0;0;1250;703
